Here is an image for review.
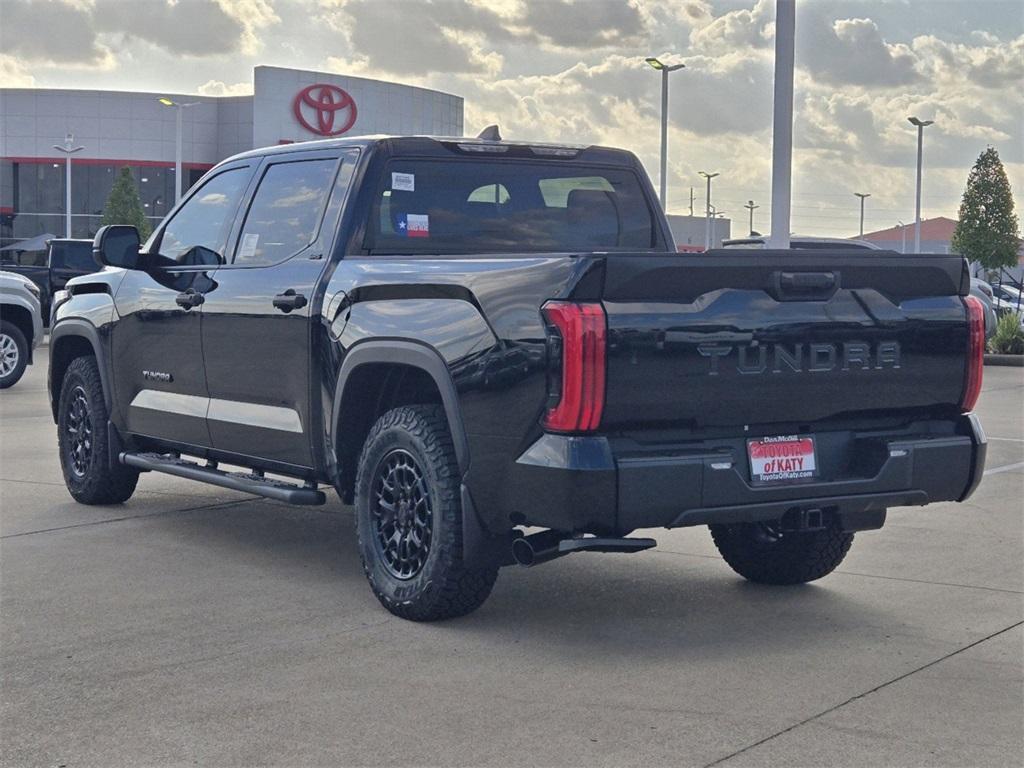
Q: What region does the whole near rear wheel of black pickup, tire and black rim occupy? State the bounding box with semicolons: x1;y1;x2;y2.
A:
355;406;498;622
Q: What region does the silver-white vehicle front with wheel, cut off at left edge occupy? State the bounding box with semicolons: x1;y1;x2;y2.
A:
0;271;43;389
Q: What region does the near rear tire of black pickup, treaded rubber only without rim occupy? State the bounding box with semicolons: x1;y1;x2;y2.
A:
355;406;498;622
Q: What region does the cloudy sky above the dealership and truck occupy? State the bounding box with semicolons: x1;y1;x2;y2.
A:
0;0;1024;236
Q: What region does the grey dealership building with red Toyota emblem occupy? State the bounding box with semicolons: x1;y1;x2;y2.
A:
0;67;463;246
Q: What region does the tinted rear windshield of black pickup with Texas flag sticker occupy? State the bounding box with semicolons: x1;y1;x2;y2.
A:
367;159;655;254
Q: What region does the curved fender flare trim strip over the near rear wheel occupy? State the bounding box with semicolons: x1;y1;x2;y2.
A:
331;340;469;476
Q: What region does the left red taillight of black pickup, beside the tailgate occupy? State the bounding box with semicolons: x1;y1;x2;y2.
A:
541;301;606;432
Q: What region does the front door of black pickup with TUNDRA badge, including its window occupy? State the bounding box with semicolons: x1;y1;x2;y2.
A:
112;164;253;447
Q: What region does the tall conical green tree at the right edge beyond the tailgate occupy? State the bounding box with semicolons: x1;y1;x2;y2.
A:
950;146;1020;270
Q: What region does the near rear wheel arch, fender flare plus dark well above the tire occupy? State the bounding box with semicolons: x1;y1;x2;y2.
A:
331;340;469;501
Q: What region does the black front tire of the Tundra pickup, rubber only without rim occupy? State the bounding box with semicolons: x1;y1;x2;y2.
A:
57;356;138;504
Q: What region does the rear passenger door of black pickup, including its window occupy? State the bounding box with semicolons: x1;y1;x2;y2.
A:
203;150;356;467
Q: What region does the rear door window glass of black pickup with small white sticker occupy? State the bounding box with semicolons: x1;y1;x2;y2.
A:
234;158;338;266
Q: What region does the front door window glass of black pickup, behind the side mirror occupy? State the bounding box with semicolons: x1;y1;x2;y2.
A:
158;168;250;266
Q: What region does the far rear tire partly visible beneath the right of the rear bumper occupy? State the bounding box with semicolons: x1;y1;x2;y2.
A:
709;521;853;585
